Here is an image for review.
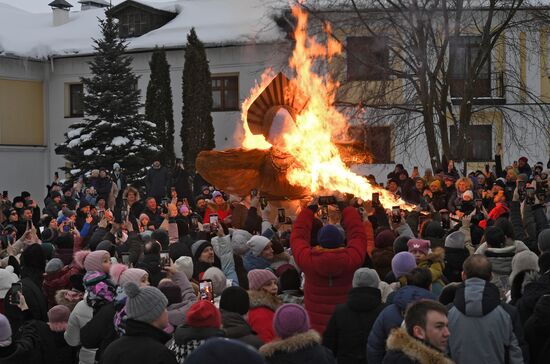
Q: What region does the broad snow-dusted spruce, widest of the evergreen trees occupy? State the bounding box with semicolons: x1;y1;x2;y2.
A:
63;16;159;183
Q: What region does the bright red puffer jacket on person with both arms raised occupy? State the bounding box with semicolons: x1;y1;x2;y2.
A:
290;207;367;334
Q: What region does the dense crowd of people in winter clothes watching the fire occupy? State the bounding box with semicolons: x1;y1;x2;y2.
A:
0;156;550;364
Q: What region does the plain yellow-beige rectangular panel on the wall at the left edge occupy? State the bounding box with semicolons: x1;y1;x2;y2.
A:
0;79;44;146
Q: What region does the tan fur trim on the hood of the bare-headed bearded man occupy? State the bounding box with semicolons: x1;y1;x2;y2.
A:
386;328;454;364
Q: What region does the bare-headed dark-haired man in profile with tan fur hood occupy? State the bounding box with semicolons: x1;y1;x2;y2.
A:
382;300;452;364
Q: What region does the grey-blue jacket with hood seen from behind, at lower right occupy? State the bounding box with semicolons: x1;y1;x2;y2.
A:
448;278;529;364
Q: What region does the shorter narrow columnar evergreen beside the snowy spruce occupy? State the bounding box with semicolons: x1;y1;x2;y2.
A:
145;48;176;166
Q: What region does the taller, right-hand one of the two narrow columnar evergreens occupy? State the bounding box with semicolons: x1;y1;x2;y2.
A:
180;28;215;172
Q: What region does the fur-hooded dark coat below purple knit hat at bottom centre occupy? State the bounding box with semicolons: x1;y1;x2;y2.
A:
260;330;336;364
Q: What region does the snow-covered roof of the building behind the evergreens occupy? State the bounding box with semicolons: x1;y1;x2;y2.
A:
0;0;288;58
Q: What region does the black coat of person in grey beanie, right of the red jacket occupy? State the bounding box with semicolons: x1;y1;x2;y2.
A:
323;287;384;364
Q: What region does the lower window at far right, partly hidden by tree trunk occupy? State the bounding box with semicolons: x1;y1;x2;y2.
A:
449;125;493;162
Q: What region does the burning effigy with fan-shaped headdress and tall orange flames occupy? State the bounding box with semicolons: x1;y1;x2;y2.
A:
196;7;405;207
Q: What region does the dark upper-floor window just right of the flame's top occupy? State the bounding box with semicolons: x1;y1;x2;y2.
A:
346;36;389;81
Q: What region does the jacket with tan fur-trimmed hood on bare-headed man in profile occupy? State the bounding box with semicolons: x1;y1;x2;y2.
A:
384;328;453;364
